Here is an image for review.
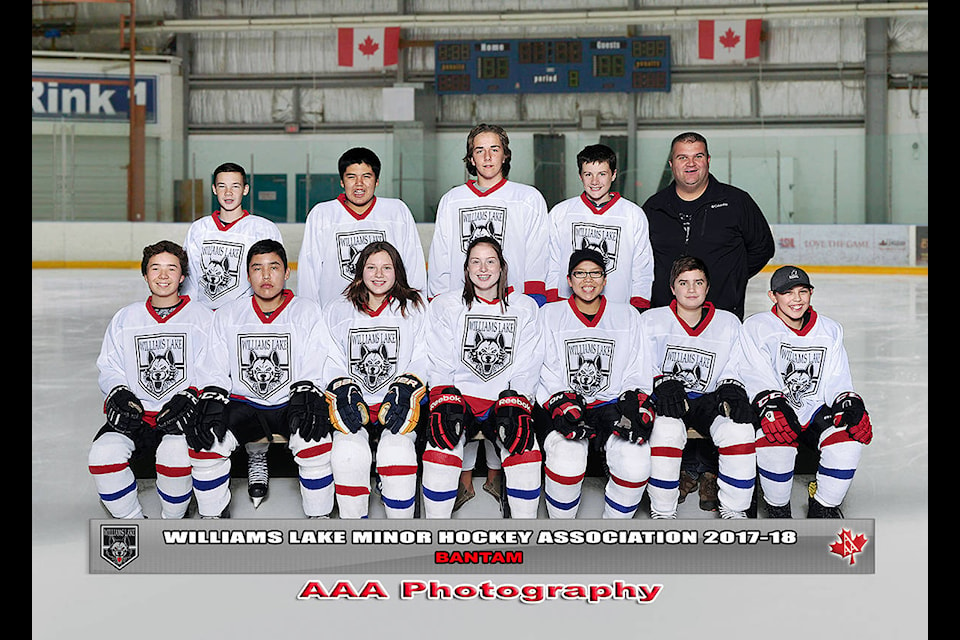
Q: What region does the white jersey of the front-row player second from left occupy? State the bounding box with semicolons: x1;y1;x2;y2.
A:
198;289;330;407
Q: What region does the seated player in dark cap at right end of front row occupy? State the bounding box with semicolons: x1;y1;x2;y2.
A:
741;265;873;518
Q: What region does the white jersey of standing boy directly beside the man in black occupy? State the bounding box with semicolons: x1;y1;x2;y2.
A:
546;193;653;308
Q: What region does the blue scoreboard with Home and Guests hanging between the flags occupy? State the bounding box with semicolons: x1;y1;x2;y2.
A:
434;36;670;94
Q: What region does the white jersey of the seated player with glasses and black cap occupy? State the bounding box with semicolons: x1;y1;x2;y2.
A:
537;296;650;407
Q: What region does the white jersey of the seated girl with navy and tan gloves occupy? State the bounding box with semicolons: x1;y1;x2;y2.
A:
323;296;427;410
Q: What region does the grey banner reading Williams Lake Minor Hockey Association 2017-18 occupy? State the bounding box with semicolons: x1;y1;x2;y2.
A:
89;519;876;575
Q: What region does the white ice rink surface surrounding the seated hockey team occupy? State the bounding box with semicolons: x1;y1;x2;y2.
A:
31;269;929;640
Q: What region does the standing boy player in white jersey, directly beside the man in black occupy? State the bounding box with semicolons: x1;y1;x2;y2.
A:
546;144;653;310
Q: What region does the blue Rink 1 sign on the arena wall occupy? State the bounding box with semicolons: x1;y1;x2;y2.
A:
33;73;157;123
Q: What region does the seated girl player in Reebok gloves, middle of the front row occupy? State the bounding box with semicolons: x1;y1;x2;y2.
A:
423;237;543;518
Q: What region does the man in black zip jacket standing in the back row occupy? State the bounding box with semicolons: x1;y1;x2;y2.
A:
643;132;774;320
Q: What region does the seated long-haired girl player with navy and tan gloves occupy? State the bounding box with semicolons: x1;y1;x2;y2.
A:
324;241;428;518
